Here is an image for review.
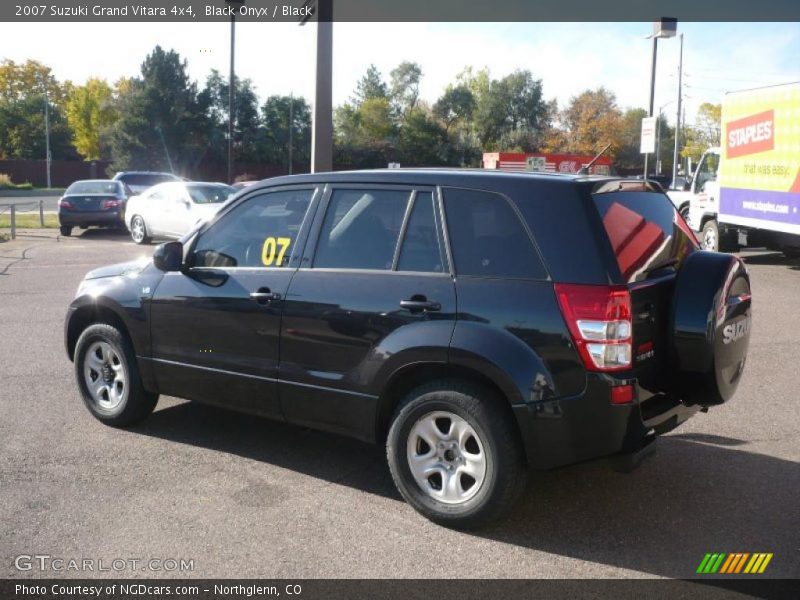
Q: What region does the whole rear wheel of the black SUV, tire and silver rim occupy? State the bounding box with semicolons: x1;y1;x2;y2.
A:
386;380;527;529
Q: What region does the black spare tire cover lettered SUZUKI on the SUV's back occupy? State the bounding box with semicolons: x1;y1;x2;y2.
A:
671;252;752;406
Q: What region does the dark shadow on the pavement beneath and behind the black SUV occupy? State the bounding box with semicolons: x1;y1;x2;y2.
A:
137;402;800;578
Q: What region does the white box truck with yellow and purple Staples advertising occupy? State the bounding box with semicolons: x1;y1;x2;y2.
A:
670;82;800;257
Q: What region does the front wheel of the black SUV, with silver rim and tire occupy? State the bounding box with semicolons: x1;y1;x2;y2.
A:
75;323;158;427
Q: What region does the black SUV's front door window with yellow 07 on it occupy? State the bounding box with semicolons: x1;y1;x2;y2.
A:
191;189;314;267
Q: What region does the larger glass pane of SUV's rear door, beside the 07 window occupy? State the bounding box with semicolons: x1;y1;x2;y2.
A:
314;189;411;270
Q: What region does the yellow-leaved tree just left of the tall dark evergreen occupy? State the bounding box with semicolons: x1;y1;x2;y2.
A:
66;78;118;160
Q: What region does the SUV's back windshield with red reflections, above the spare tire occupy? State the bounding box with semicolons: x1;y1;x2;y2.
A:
592;191;697;283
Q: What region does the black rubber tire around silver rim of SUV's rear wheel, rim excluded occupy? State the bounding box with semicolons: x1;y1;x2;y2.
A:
386;380;528;529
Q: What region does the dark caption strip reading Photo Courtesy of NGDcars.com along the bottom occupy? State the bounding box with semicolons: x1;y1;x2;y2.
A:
0;575;798;600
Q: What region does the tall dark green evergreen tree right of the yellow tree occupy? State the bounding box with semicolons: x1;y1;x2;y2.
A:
110;46;212;173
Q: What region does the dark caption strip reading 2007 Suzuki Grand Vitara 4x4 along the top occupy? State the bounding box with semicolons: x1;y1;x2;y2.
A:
0;0;800;21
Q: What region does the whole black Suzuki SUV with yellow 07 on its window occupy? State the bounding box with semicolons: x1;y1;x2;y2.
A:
65;170;751;527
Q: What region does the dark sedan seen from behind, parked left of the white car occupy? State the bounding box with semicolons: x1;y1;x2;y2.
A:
58;179;130;236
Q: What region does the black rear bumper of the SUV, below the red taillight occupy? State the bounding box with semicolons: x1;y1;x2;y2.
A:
512;374;700;469
